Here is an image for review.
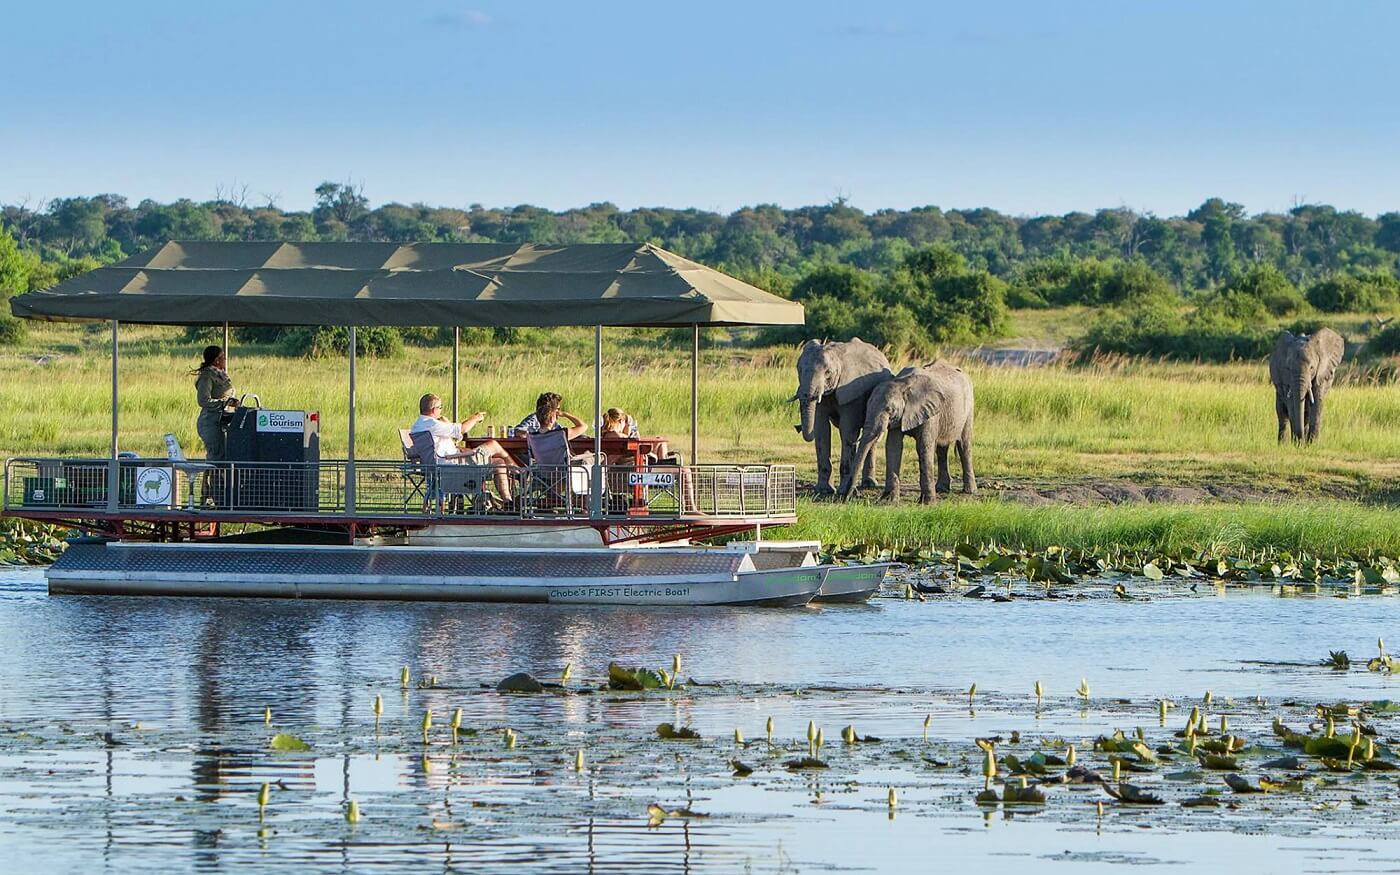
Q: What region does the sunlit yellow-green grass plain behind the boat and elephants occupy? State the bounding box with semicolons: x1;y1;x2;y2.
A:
0;320;1400;501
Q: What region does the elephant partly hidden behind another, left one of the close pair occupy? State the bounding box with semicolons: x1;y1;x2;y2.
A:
788;337;890;496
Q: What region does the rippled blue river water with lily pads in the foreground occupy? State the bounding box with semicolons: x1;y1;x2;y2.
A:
0;570;1400;872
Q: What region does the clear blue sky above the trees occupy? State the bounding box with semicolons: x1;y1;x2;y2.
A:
0;0;1400;216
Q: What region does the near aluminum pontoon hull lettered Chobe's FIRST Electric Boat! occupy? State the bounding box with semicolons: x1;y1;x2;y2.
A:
48;542;826;606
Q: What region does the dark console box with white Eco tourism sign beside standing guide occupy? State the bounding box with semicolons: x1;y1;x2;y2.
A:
224;407;321;511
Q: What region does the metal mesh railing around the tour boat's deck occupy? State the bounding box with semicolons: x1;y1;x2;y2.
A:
3;458;797;521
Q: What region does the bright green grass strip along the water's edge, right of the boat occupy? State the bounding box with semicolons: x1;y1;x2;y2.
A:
783;498;1400;557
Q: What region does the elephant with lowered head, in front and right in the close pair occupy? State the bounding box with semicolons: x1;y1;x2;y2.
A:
855;361;977;504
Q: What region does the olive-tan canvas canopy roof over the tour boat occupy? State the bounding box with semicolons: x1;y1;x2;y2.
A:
10;242;802;326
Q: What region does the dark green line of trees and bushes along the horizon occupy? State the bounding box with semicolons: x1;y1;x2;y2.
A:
0;182;1400;357
